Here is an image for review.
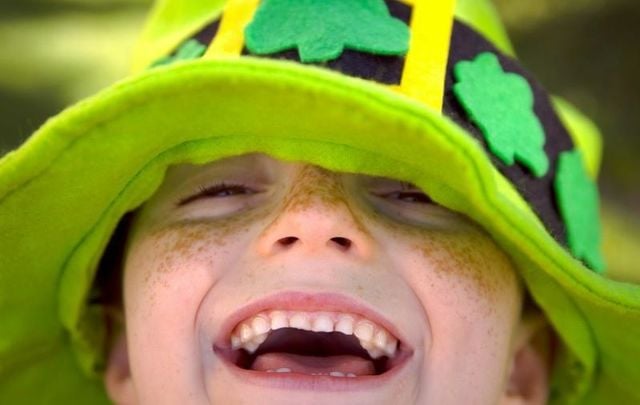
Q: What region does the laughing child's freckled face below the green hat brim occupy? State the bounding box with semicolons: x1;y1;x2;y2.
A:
107;155;544;404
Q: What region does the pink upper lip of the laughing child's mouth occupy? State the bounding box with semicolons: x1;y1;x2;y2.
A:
215;291;408;349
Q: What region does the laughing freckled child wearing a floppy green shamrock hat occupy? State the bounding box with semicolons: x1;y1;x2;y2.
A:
0;0;640;404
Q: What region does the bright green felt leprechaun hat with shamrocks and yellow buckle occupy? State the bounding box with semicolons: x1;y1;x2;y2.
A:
0;0;640;404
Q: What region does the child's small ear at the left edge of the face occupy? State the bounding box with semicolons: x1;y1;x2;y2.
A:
104;332;136;405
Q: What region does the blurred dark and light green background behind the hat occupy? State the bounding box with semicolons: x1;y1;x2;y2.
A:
0;0;640;281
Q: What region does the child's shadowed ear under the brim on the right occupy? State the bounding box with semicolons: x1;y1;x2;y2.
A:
501;313;552;405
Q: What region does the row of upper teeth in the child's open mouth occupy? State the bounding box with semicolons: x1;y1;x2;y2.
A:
231;311;398;359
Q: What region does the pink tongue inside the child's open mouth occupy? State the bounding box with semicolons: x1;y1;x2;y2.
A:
251;353;375;375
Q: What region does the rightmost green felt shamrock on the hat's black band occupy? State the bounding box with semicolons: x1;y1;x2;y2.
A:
554;151;604;272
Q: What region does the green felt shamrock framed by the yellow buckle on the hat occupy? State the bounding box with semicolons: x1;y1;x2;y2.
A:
245;0;409;62
